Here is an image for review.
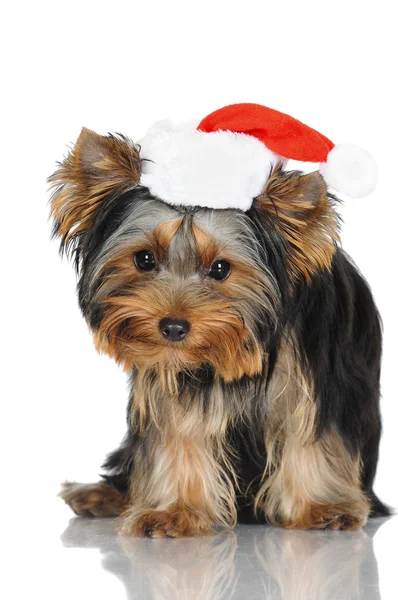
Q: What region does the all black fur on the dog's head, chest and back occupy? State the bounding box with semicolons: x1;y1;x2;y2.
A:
54;168;389;522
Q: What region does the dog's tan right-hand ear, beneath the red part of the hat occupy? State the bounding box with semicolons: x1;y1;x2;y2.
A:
255;165;339;281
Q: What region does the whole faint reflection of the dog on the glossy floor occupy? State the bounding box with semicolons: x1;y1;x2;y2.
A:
62;518;384;600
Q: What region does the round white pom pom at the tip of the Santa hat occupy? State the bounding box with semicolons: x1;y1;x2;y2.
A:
319;144;377;198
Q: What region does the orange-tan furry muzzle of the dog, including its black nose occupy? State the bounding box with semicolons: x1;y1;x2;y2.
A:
95;291;264;381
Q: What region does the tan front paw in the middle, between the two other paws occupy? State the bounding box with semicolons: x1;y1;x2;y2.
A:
120;508;212;538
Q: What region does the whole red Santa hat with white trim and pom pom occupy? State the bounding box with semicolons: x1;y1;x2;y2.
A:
140;104;377;211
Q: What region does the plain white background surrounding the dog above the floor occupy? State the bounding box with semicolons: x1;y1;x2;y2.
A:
0;0;398;597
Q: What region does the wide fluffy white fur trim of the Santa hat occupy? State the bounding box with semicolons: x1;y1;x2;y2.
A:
139;121;280;211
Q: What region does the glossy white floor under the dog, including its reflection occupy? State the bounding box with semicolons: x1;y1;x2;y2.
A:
10;513;398;600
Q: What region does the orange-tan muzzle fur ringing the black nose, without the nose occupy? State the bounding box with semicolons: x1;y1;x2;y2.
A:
95;282;263;381
